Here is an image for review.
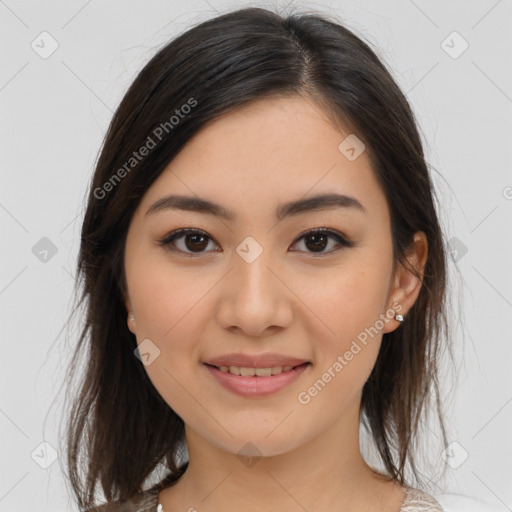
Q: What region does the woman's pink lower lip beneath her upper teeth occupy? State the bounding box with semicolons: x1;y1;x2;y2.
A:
205;363;310;398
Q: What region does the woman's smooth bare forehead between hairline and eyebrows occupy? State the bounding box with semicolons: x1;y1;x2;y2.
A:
136;97;387;224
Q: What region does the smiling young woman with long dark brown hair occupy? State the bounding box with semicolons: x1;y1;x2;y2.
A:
62;8;490;512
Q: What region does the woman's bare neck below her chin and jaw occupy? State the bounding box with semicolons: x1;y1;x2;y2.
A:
159;400;404;512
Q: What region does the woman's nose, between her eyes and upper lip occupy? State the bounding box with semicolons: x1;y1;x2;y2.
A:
216;240;294;337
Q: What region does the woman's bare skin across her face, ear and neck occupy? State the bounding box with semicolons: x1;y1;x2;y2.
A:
125;97;427;512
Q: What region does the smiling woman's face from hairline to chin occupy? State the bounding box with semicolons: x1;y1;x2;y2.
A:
125;97;420;455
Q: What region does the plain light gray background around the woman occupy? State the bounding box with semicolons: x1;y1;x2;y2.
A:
0;0;512;512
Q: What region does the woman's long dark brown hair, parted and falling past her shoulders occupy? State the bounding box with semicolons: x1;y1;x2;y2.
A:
62;8;447;508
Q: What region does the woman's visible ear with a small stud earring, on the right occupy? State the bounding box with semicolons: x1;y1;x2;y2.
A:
383;231;428;333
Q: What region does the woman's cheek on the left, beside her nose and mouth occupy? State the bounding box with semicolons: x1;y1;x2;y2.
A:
127;262;214;418
